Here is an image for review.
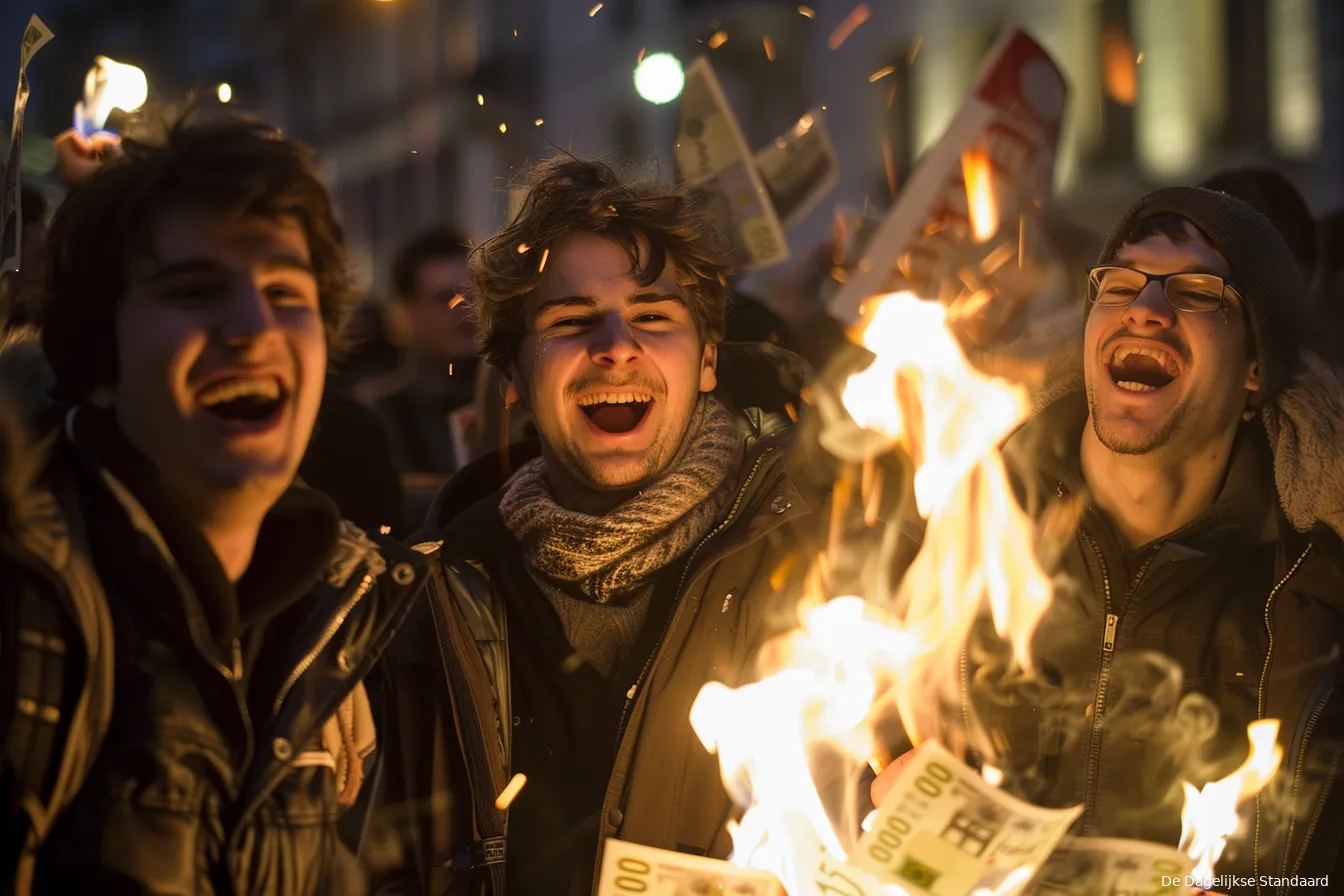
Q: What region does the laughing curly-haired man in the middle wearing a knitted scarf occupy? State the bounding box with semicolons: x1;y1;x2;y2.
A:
384;159;812;896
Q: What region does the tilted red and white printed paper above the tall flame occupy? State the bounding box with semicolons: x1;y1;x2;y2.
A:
831;28;1068;321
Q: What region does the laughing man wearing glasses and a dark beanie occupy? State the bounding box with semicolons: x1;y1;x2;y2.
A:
875;187;1344;893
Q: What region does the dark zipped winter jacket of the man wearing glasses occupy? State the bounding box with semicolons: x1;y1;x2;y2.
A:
983;354;1344;892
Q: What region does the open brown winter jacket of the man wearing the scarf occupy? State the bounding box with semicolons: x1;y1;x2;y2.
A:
382;416;824;896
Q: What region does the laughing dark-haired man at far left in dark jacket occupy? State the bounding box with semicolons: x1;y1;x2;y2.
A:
0;120;425;896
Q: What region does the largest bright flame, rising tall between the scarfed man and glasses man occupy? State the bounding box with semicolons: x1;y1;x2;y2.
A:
691;293;1051;896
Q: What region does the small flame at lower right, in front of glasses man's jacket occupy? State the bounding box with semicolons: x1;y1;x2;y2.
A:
1180;719;1284;880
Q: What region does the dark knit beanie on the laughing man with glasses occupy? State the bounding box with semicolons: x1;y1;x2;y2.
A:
1085;187;1306;402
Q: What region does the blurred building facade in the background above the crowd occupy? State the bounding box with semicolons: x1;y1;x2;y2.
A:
7;0;1344;293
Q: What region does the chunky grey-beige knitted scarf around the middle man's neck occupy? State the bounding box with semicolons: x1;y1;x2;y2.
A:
500;395;743;676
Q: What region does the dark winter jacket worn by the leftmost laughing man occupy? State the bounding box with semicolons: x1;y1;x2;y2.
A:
0;338;426;895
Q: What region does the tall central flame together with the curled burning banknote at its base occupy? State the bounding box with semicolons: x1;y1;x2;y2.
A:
691;293;1078;896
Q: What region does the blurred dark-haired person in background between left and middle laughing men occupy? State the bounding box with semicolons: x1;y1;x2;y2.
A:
360;230;477;476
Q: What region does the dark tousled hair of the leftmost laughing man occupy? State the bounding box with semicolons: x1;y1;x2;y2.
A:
38;113;356;400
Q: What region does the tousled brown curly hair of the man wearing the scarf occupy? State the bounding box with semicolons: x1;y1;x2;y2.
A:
466;156;728;372
